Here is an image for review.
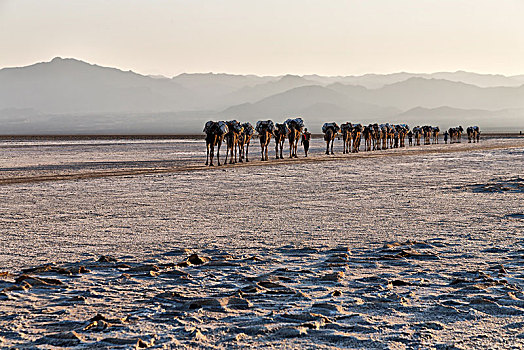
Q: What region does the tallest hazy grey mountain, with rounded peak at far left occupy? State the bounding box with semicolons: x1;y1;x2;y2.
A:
0;58;197;113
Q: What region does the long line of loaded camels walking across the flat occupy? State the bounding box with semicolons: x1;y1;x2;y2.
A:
204;117;480;166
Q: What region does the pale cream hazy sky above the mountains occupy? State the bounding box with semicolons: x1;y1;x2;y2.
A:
0;0;524;76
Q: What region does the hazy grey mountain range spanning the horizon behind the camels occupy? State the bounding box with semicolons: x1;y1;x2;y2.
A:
0;57;524;134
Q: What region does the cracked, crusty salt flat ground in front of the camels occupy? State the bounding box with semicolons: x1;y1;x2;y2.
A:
0;139;524;349
